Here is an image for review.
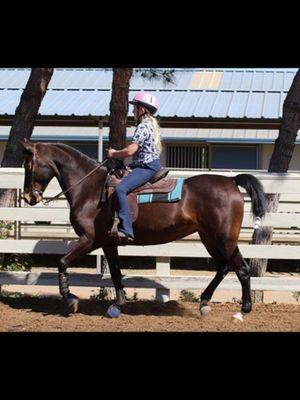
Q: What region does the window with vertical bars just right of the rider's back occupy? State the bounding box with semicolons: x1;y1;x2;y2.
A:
166;144;208;168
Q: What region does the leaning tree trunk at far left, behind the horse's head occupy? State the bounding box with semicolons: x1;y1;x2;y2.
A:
0;68;53;265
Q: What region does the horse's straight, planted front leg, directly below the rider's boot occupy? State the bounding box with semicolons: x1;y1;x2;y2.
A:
103;247;126;306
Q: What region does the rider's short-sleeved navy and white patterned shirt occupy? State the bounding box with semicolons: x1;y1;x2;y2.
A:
132;117;159;165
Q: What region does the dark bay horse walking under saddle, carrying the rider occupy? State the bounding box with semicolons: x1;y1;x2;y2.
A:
22;140;266;320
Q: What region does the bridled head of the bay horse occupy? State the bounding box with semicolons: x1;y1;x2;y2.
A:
20;139;54;206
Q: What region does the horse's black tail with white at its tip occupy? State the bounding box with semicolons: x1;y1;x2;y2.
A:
233;174;267;228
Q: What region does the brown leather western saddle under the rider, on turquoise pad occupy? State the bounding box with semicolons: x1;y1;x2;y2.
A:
102;161;176;240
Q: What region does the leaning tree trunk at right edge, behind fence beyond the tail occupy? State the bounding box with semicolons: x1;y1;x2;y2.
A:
250;70;300;302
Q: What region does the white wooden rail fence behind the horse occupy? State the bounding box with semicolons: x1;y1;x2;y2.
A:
0;168;300;301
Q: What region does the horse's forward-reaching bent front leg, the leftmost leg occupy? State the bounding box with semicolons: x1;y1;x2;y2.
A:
58;235;94;313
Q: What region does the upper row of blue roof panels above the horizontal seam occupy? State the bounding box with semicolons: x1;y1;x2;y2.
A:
0;68;297;91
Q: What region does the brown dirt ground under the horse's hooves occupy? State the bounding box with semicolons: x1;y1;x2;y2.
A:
0;296;300;332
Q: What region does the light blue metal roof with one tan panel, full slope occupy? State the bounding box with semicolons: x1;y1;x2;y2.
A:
0;68;297;119
